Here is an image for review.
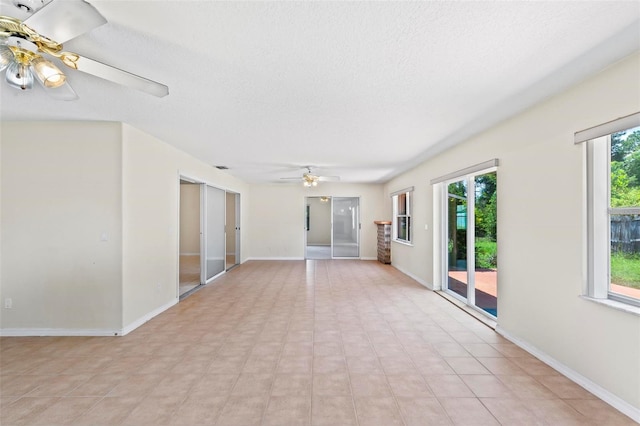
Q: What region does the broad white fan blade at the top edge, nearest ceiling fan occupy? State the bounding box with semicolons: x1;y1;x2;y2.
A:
24;0;107;44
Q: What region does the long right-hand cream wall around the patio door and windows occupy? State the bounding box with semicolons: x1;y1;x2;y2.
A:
385;54;640;410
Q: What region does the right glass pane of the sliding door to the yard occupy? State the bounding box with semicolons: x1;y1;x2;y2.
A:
474;172;498;317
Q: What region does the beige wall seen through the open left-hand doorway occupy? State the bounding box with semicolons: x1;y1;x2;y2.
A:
180;183;200;255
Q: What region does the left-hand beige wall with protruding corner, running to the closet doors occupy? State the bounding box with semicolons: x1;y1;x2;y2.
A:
0;122;251;335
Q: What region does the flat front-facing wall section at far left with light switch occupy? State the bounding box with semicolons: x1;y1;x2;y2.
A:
0;122;122;335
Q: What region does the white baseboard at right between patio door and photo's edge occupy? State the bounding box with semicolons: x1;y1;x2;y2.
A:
496;326;640;423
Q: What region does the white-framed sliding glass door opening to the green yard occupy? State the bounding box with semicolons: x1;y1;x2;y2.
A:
444;171;498;317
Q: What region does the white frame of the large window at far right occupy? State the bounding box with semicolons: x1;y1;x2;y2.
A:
576;114;640;314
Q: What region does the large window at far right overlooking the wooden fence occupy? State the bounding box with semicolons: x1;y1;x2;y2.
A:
576;114;640;306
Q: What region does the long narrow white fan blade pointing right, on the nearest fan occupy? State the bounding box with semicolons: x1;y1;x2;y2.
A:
60;52;169;98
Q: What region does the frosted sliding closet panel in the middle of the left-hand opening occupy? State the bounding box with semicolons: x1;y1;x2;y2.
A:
205;186;226;280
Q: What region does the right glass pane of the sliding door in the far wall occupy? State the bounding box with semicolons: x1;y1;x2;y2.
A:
332;197;360;257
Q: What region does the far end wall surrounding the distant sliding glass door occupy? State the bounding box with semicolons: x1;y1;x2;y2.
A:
248;182;386;259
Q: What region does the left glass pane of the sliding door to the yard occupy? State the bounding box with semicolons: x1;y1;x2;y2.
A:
447;181;468;299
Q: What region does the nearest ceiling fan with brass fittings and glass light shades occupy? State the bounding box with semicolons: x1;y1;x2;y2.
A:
0;0;169;100
